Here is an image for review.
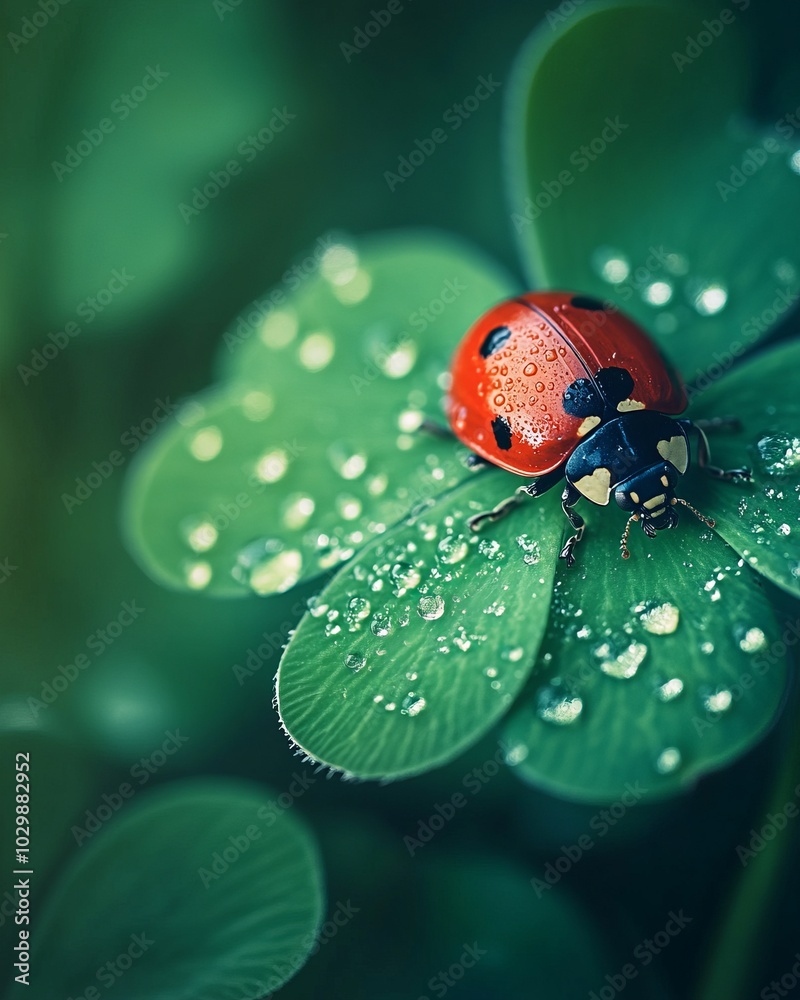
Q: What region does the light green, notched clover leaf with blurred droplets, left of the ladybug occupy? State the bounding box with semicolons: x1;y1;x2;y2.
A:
125;234;510;595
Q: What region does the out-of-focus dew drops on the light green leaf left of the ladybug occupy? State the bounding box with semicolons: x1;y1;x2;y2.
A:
166;243;463;595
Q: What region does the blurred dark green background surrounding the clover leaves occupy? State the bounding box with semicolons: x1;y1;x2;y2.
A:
0;0;800;997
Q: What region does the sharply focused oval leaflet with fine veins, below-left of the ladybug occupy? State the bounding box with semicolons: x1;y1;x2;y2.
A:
277;471;561;778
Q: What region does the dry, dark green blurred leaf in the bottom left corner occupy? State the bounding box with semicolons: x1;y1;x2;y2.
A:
17;781;322;1000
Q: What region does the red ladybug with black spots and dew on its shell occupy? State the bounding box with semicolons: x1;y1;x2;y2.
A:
446;292;750;566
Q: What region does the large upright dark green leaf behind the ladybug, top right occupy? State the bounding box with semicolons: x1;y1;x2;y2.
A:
508;3;800;378
